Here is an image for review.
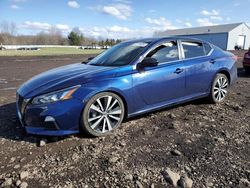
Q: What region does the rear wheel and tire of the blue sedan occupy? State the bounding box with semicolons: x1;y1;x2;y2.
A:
209;73;229;104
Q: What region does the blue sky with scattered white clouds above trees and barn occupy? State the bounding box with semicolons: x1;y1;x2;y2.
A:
0;0;250;39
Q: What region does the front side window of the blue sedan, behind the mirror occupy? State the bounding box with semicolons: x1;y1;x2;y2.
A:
147;41;179;63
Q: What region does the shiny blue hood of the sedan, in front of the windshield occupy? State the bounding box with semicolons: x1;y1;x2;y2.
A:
18;63;117;98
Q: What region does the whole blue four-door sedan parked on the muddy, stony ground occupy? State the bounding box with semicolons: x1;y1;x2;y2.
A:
17;37;237;136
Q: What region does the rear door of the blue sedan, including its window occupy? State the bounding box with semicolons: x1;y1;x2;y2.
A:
181;40;215;96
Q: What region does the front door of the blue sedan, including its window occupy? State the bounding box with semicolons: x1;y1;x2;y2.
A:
133;41;185;111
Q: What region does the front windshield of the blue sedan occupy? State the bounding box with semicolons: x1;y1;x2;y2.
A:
88;42;149;66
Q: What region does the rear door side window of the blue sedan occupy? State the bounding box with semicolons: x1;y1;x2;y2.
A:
181;41;205;58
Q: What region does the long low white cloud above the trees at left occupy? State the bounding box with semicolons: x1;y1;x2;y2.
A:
18;21;71;33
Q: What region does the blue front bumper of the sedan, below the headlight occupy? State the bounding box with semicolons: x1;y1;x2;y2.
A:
16;94;83;136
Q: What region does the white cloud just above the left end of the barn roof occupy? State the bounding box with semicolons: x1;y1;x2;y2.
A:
145;17;177;30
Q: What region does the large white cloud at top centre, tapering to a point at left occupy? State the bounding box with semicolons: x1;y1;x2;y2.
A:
90;3;132;20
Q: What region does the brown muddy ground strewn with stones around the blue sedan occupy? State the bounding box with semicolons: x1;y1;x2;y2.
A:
0;52;250;187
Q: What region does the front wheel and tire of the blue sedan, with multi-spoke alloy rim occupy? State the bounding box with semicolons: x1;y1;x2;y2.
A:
80;92;125;137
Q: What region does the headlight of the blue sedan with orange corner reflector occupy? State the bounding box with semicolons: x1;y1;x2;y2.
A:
31;86;80;104
